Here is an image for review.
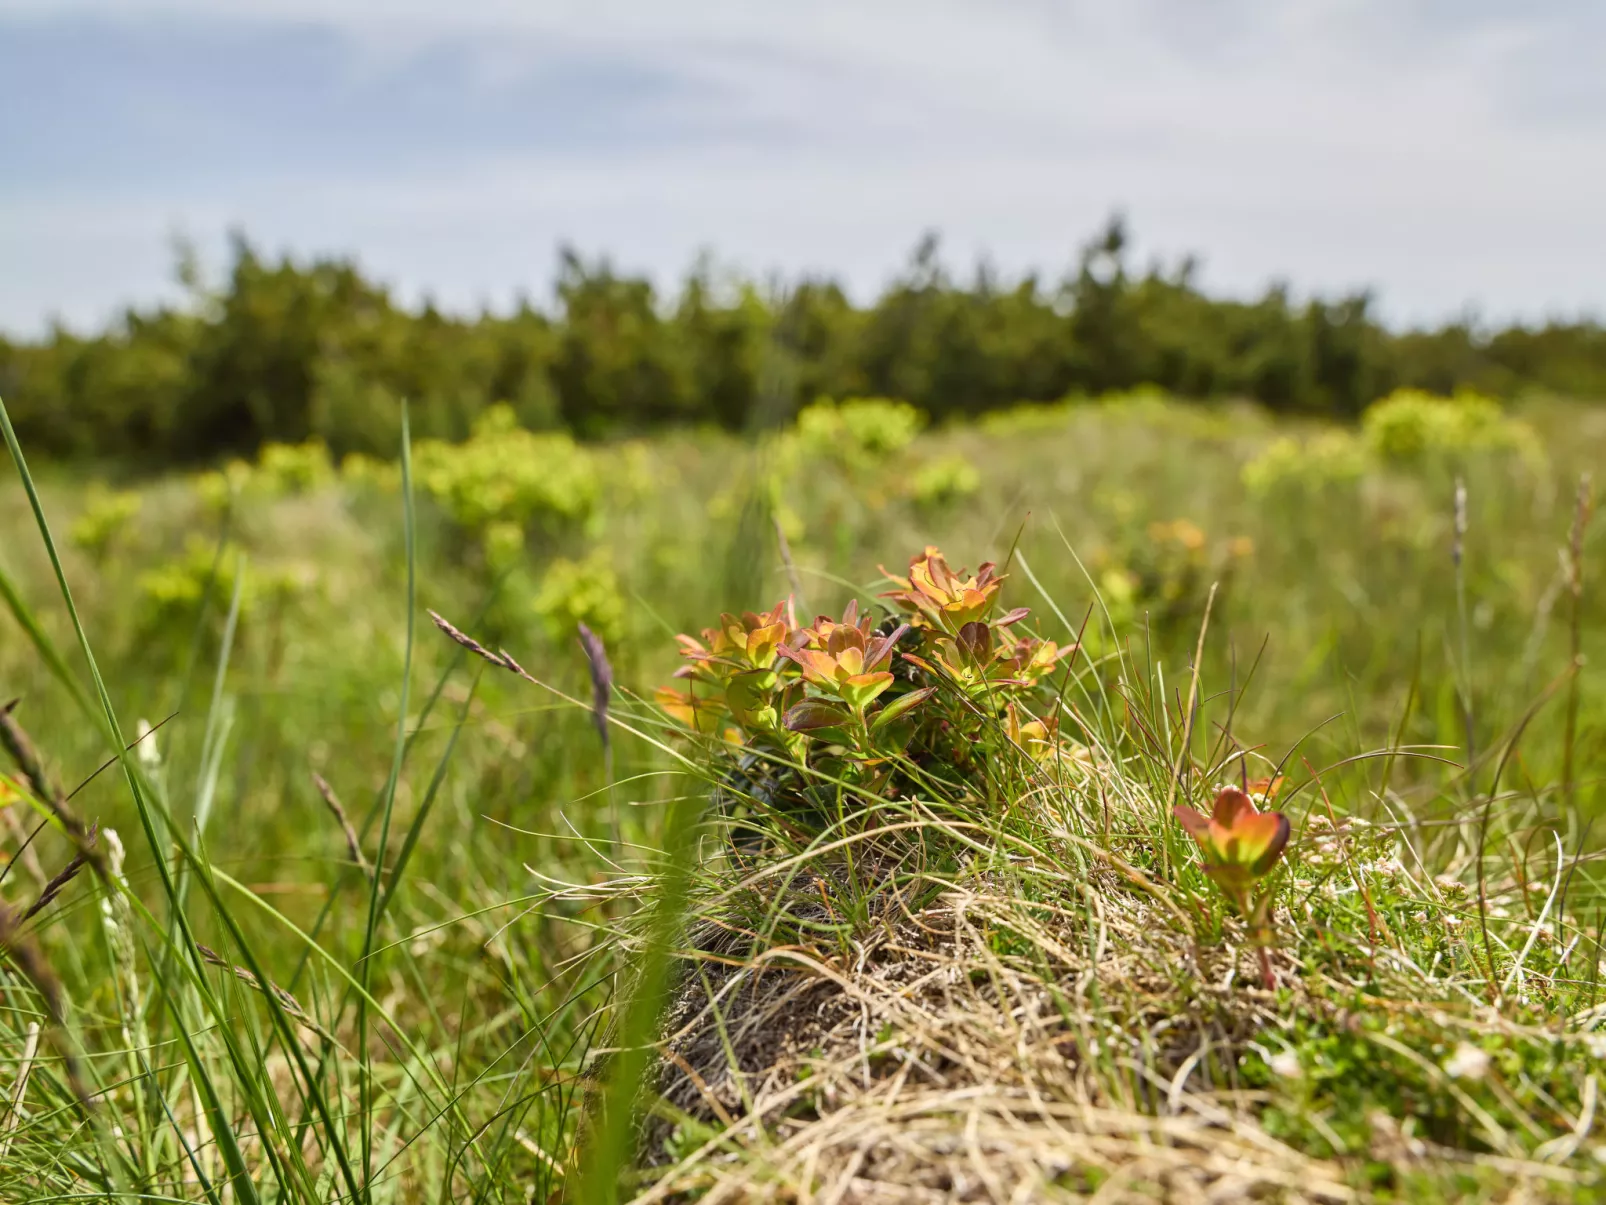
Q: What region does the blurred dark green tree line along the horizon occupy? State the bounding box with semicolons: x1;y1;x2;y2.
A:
0;219;1606;464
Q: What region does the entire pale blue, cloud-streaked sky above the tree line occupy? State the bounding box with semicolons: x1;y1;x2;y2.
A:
0;0;1606;336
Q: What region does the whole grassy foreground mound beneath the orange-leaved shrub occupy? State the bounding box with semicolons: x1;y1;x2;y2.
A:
497;539;1601;1202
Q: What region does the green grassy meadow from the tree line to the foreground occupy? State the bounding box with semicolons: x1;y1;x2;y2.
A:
0;394;1606;1202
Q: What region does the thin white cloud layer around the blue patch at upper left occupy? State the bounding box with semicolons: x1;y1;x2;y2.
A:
0;0;1606;328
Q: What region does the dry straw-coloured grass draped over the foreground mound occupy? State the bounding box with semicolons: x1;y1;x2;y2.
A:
623;829;1585;1203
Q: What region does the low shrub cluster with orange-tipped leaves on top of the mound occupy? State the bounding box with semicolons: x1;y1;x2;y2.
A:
657;548;1074;848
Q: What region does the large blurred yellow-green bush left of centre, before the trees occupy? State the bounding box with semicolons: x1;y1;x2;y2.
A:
413;405;599;530
